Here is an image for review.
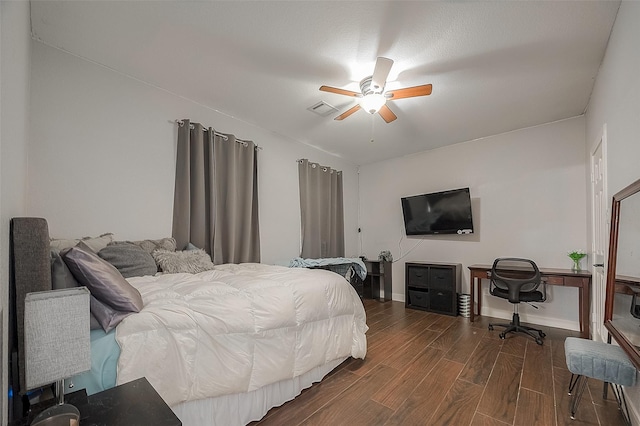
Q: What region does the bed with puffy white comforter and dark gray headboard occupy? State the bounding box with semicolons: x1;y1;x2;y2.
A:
10;218;367;426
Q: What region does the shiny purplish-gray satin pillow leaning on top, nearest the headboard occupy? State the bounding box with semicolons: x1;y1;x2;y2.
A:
60;242;143;312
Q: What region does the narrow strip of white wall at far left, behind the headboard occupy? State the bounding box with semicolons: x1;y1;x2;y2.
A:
0;1;31;424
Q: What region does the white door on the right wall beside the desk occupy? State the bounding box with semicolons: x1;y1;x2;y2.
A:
591;124;610;342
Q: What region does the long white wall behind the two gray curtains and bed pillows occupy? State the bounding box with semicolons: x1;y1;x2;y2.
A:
28;42;358;264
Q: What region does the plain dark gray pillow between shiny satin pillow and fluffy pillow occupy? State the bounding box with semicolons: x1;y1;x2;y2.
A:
98;243;158;278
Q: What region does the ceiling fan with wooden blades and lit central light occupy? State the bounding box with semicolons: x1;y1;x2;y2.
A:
320;56;431;123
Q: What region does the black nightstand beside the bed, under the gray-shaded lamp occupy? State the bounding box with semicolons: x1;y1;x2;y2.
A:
9;377;182;426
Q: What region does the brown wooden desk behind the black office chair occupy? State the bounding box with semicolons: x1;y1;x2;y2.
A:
469;265;591;339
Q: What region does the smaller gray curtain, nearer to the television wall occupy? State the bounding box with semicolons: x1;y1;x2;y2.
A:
298;159;344;259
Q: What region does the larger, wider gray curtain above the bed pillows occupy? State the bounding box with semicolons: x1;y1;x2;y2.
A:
173;120;260;264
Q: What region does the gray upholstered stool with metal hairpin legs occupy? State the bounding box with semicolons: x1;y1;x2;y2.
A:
564;337;636;419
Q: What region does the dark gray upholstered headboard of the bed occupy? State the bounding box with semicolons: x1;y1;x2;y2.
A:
9;217;51;416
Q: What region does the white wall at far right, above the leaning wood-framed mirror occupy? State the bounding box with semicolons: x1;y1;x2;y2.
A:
586;1;640;425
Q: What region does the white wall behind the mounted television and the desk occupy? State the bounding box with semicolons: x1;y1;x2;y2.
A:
360;117;587;329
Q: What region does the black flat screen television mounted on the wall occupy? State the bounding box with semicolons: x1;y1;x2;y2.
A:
402;188;473;235
